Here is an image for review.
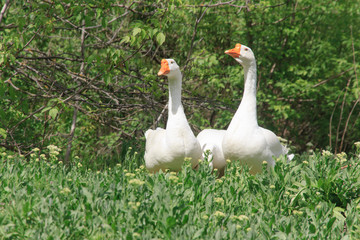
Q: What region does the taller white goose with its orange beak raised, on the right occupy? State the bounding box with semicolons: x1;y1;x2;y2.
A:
222;44;287;174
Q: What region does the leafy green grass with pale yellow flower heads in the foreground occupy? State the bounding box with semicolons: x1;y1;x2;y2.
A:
0;147;360;239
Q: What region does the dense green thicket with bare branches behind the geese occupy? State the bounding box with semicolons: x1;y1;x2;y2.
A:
0;0;360;162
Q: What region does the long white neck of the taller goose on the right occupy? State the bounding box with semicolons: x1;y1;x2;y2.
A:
229;60;258;130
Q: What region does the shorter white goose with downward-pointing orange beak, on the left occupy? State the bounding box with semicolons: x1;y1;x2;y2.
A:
144;59;201;172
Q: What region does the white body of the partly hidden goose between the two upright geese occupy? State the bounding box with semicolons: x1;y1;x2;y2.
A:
196;129;226;177
